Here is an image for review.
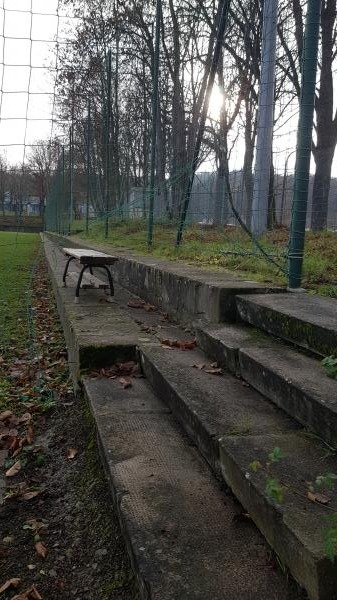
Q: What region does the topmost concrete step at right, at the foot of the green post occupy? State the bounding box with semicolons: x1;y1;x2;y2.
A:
236;293;337;356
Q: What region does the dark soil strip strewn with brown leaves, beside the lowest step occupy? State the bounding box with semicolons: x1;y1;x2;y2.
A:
0;263;138;600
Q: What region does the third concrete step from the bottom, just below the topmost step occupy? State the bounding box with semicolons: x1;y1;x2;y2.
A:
196;325;337;447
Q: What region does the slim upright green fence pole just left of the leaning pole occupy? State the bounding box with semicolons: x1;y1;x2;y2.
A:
147;0;161;248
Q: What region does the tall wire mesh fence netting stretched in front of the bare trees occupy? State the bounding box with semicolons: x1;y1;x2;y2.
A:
0;0;337;290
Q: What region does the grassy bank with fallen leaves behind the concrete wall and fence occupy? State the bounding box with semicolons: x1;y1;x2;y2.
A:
74;220;337;298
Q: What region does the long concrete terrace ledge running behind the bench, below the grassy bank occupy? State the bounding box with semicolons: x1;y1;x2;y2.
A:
46;234;280;324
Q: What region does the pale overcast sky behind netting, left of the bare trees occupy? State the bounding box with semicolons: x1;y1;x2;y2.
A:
0;0;73;163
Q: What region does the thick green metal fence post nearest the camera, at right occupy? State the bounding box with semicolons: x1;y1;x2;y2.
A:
288;0;321;290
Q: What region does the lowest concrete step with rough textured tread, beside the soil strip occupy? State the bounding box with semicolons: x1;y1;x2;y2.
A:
83;379;294;600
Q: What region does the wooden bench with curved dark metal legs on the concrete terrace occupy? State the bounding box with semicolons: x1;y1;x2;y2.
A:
62;248;118;303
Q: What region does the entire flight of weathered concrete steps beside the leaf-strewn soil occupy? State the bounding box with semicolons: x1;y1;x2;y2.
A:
47;236;337;600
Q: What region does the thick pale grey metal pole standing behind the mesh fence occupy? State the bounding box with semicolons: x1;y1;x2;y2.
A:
248;0;278;236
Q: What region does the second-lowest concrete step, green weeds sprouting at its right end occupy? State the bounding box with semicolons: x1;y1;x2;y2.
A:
140;345;337;600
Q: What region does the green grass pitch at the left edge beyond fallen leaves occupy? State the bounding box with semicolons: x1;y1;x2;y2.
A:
0;231;41;354
